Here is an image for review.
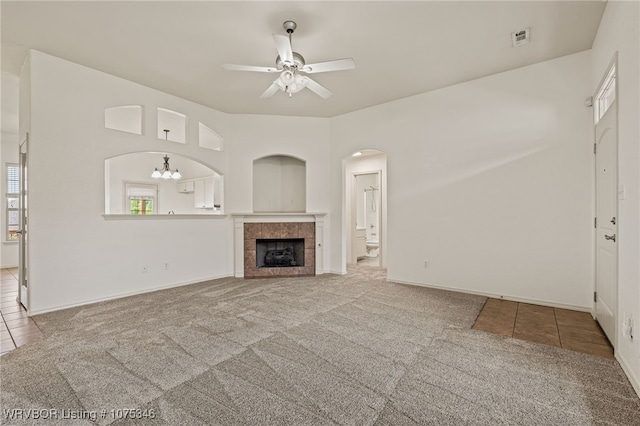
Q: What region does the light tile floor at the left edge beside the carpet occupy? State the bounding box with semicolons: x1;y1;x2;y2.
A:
0;268;42;355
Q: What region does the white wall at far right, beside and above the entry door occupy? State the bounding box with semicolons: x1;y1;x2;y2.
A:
590;1;640;395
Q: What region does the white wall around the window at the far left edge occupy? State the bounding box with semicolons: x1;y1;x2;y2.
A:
0;71;19;268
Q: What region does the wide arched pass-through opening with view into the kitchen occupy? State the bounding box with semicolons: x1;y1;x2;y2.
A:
104;152;224;215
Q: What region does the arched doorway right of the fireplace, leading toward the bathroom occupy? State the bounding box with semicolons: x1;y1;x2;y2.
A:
345;150;387;267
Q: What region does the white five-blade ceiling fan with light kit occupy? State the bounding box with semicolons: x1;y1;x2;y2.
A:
222;21;356;99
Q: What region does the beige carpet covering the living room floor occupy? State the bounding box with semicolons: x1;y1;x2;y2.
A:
0;267;640;426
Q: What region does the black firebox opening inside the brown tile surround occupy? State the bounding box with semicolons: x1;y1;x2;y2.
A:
256;238;304;268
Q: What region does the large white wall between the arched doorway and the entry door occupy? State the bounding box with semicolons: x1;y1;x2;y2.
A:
331;52;592;310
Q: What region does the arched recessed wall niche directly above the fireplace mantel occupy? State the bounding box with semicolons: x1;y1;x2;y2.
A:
253;155;307;213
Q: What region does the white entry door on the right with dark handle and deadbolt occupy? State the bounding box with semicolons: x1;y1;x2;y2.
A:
595;102;618;348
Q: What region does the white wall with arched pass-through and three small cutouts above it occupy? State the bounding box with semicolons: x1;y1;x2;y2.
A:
20;52;232;314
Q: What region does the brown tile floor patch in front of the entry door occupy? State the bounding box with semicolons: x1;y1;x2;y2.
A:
473;299;613;358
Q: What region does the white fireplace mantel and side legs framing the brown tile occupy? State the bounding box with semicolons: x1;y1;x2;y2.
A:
231;213;326;277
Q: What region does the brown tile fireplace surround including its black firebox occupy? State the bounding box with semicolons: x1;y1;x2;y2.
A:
244;222;316;278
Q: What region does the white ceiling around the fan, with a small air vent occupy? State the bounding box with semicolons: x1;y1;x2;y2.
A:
0;0;606;117
